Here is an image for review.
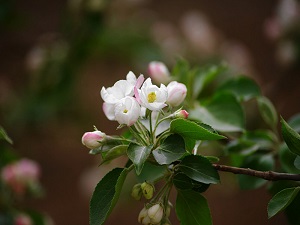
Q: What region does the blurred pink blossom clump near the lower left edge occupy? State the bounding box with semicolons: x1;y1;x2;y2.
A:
1;159;40;195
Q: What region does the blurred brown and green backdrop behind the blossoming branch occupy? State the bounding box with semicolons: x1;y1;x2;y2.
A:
0;0;300;225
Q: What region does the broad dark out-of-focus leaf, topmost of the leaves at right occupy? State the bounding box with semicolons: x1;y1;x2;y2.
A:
217;76;261;101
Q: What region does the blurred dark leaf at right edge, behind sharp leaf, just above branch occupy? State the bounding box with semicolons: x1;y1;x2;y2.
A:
279;143;300;174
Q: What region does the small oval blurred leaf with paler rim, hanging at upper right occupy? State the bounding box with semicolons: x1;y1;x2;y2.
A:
257;96;278;128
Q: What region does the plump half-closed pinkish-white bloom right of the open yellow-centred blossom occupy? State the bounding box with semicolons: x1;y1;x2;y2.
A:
167;81;187;106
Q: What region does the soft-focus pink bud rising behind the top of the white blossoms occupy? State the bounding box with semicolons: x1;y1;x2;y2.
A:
148;61;170;84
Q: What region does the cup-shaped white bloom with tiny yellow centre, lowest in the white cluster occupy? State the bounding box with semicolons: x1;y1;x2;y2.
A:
115;96;141;126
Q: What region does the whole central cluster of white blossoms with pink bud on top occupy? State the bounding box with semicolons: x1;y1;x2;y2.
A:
100;62;187;126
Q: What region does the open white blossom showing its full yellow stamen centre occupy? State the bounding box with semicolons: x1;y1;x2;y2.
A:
135;78;168;111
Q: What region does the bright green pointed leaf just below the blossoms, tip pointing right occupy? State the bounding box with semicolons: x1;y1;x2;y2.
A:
170;119;225;140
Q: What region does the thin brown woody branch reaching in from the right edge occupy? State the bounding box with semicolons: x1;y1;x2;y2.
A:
213;164;300;181
